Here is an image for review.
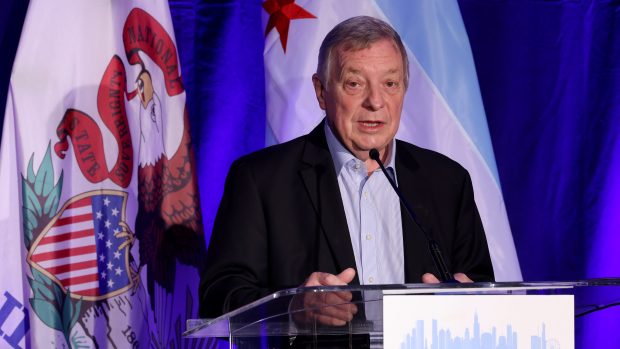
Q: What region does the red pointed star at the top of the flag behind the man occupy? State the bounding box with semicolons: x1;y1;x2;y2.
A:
263;0;316;52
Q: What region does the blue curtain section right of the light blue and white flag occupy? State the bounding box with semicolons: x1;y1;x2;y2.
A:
459;0;620;342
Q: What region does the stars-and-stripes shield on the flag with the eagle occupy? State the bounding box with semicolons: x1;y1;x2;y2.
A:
28;190;133;301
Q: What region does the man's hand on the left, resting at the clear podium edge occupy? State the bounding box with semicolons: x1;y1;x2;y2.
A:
291;268;357;326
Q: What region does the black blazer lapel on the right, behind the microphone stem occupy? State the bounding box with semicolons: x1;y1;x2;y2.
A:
396;141;434;283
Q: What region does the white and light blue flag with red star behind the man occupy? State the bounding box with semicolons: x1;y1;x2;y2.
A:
263;0;521;281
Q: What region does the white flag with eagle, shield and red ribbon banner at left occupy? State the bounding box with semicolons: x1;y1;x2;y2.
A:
0;0;207;348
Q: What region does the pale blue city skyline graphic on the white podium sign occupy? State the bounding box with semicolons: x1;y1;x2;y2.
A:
400;312;561;349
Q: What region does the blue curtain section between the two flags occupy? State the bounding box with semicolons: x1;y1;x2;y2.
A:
169;0;265;241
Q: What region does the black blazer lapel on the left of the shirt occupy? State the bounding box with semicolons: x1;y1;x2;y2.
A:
300;121;359;284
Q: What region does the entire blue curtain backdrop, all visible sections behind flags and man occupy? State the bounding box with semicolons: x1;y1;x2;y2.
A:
0;0;620;348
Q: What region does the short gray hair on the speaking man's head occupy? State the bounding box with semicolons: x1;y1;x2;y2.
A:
316;16;409;88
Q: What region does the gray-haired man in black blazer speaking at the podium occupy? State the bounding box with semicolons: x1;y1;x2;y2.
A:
200;17;493;325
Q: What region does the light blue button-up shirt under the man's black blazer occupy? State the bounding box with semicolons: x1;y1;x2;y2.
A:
325;122;405;285
